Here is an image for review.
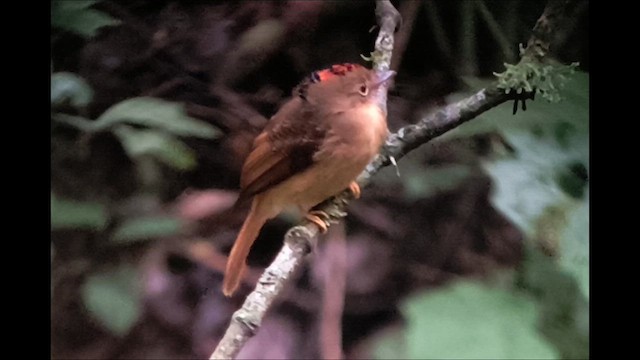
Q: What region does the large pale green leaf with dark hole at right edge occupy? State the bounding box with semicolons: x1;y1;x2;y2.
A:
478;75;589;299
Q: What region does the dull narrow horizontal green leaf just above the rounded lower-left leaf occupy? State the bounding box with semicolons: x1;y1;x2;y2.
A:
111;216;183;243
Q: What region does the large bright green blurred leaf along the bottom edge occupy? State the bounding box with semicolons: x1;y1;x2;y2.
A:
376;282;558;359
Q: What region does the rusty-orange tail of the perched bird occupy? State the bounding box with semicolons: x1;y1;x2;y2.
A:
222;198;267;296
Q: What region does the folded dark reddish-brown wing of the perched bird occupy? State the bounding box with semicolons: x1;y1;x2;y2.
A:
238;98;327;202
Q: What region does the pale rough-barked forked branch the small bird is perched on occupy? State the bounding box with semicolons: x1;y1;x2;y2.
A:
210;0;584;359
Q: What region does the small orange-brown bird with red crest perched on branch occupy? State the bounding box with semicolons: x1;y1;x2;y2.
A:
222;63;395;296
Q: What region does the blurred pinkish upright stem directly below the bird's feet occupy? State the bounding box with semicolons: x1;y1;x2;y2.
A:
320;222;347;360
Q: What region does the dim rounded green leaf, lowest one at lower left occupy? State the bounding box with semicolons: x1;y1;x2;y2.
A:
81;266;142;336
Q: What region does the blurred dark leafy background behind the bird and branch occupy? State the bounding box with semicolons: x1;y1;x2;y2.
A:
51;0;589;359
